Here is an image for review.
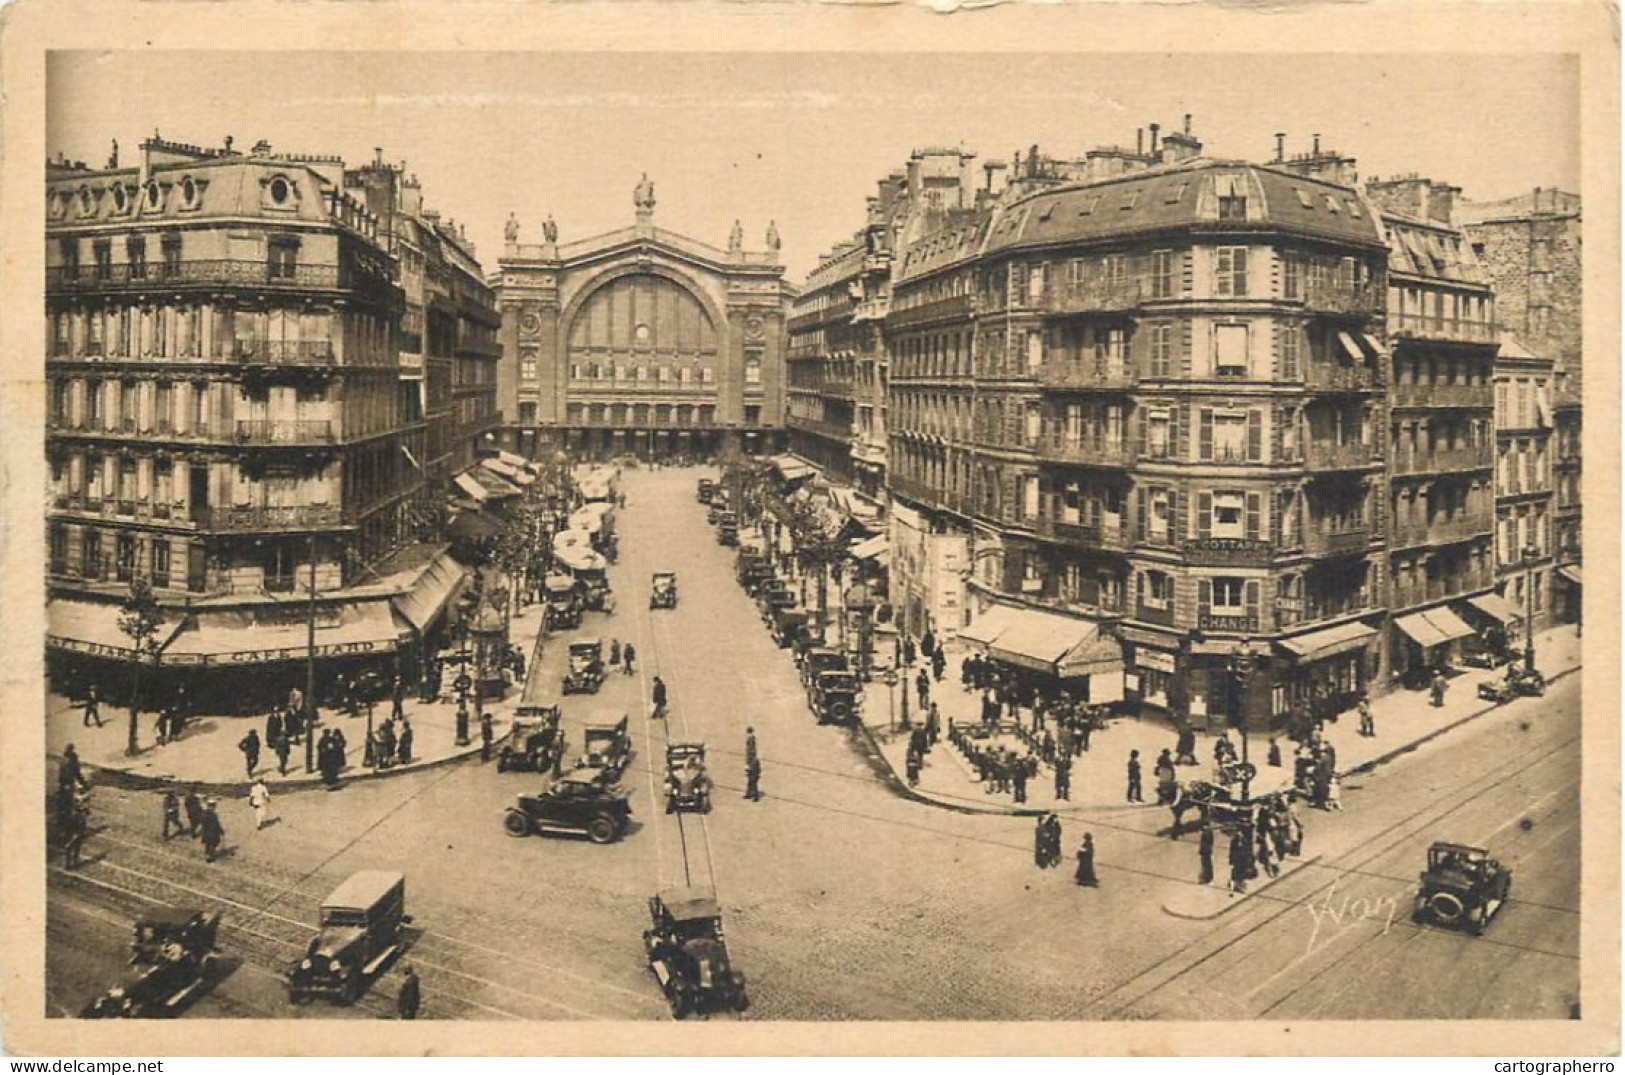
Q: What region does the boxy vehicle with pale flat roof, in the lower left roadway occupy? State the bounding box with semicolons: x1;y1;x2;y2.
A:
288;870;411;1005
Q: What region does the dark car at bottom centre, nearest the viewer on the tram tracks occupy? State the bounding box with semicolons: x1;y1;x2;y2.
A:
644;887;751;1018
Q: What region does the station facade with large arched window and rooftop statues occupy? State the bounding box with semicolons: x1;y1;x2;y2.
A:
496;179;791;458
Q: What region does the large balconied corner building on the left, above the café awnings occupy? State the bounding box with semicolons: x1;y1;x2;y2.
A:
46;136;419;708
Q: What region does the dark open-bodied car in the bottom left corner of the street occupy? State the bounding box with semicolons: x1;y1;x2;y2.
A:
80;906;219;1020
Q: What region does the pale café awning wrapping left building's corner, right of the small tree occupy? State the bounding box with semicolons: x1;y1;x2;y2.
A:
164;601;400;667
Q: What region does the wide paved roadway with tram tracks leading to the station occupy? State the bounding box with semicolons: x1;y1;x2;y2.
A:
47;469;1580;1020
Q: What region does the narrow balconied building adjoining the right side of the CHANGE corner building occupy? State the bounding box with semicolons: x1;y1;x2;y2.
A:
1365;175;1500;684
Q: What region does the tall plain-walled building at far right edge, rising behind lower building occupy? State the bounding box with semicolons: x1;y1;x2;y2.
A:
1459;187;1584;622
